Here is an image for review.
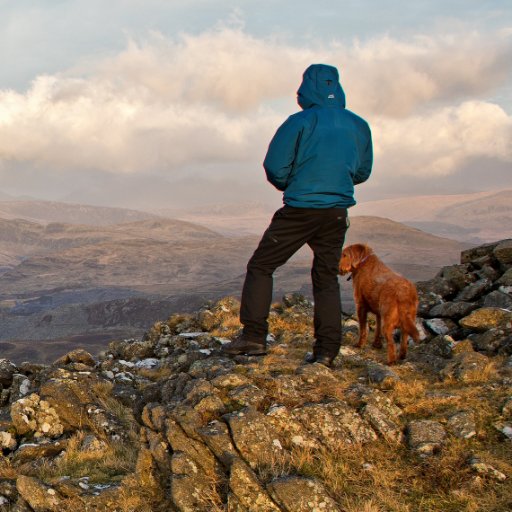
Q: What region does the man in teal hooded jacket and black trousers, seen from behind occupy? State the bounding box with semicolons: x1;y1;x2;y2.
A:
223;64;373;366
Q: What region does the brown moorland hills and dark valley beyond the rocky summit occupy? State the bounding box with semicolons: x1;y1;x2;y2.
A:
0;217;467;343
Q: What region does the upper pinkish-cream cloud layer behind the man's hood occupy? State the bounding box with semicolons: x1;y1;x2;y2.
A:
85;27;512;117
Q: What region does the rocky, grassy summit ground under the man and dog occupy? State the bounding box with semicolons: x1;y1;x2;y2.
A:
0;240;512;512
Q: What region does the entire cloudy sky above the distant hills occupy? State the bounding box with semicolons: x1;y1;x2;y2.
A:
0;0;512;209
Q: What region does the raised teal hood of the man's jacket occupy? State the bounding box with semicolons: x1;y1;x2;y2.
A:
297;64;345;109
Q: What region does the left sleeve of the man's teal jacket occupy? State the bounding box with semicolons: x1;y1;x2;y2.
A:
263;116;303;191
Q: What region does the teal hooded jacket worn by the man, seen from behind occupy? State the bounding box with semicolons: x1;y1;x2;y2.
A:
263;64;373;208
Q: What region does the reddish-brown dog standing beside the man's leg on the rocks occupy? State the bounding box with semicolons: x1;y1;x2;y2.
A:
339;244;419;364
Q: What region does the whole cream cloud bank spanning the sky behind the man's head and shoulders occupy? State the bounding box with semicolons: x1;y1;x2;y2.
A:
0;26;512;184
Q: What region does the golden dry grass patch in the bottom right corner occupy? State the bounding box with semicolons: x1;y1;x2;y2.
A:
254;441;512;512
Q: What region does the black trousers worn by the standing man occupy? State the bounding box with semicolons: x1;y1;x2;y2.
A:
240;206;348;357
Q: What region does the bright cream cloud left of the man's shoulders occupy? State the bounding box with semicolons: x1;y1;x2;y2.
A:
0;72;277;172
